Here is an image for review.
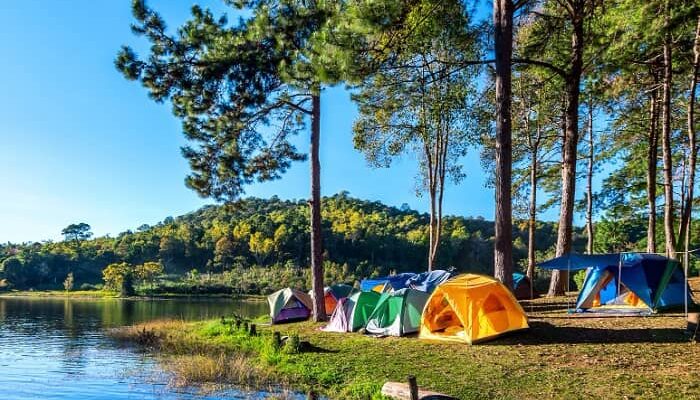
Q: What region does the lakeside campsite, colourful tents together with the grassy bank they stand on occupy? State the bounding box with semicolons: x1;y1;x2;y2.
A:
104;253;700;399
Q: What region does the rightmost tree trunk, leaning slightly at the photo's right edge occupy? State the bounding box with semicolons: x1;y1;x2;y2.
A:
678;18;700;268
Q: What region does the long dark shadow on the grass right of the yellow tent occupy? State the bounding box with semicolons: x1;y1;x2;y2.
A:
484;321;689;346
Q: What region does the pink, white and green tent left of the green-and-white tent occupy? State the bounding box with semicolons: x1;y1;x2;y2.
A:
323;292;380;332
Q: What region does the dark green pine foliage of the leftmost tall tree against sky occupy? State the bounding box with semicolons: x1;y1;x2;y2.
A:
115;0;340;200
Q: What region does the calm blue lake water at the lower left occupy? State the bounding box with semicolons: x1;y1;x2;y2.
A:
0;298;296;400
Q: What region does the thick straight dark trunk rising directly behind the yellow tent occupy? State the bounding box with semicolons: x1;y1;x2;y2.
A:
493;0;514;288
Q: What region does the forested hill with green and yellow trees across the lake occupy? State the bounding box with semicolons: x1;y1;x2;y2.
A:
0;193;572;292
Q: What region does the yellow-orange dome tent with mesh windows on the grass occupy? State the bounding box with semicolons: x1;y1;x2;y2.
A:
419;274;528;344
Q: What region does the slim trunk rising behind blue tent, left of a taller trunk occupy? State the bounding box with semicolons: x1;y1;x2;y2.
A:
647;85;659;253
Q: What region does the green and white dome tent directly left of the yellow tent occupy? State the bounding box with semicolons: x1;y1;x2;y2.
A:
365;289;430;336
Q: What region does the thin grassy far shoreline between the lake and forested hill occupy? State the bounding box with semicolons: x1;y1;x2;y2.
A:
0;290;267;302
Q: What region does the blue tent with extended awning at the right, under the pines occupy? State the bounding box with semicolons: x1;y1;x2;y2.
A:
538;253;693;311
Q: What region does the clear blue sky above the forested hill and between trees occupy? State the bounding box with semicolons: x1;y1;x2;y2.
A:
0;0;568;242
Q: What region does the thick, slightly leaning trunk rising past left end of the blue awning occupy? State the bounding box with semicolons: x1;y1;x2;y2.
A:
547;9;584;296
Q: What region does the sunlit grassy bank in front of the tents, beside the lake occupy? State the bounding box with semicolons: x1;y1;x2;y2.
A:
108;299;700;399
